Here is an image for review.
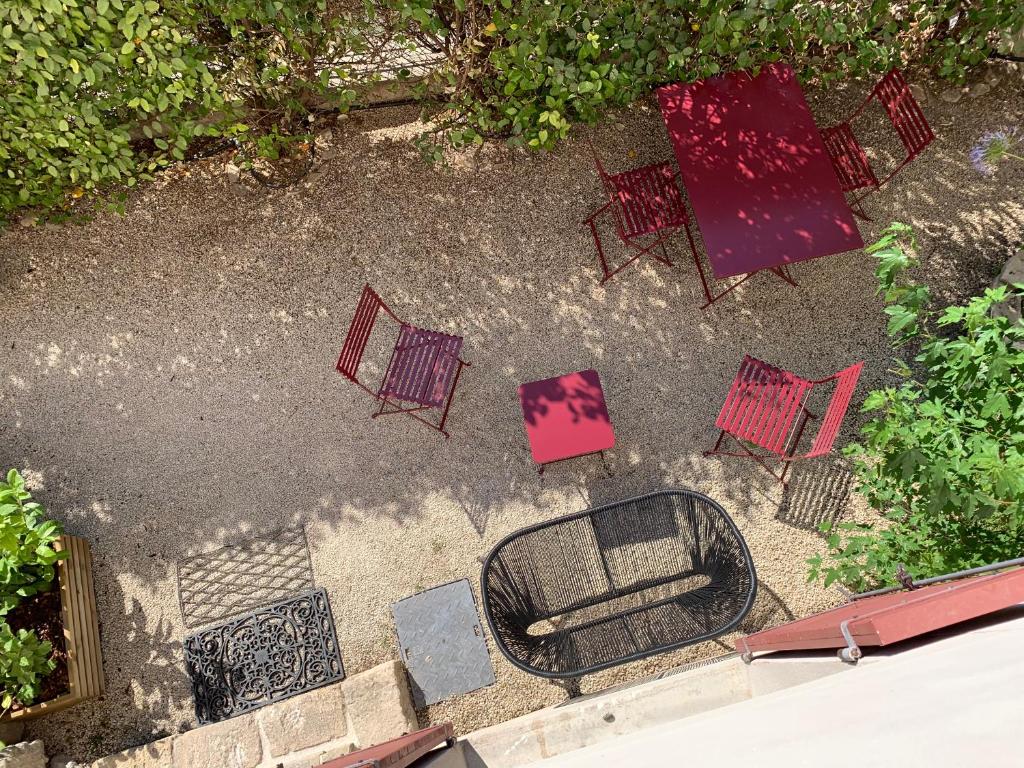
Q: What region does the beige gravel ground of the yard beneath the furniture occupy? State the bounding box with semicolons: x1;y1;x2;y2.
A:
0;63;1024;759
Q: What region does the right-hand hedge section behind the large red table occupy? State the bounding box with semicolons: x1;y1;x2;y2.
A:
391;0;1024;157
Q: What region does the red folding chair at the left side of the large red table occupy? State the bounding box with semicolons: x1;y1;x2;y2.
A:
585;147;697;284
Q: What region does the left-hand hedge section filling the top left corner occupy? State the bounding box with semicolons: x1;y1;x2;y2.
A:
0;0;369;222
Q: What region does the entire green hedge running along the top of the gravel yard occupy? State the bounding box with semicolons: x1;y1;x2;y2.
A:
0;0;1024;220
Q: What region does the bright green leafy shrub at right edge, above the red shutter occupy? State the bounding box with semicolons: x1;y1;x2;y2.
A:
808;224;1024;590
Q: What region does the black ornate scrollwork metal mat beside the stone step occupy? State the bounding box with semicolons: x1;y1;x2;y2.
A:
184;588;345;724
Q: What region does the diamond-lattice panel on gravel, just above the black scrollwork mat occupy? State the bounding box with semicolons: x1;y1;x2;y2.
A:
178;527;315;628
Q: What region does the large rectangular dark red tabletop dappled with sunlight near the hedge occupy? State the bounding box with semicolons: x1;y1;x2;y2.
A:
657;63;864;279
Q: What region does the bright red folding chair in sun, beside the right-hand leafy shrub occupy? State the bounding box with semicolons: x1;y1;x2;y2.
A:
705;355;864;485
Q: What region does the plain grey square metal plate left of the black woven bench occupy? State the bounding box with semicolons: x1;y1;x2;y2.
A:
391;579;495;708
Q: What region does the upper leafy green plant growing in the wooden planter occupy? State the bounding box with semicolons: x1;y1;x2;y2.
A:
0;469;67;616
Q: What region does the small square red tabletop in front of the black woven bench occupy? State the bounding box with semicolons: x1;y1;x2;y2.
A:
519;370;615;464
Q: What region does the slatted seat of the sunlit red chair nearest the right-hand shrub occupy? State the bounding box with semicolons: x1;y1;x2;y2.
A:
715;354;812;456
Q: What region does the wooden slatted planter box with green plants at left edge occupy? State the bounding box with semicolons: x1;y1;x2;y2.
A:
0;469;103;720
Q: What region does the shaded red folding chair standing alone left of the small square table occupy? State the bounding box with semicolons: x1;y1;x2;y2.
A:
337;285;469;437
